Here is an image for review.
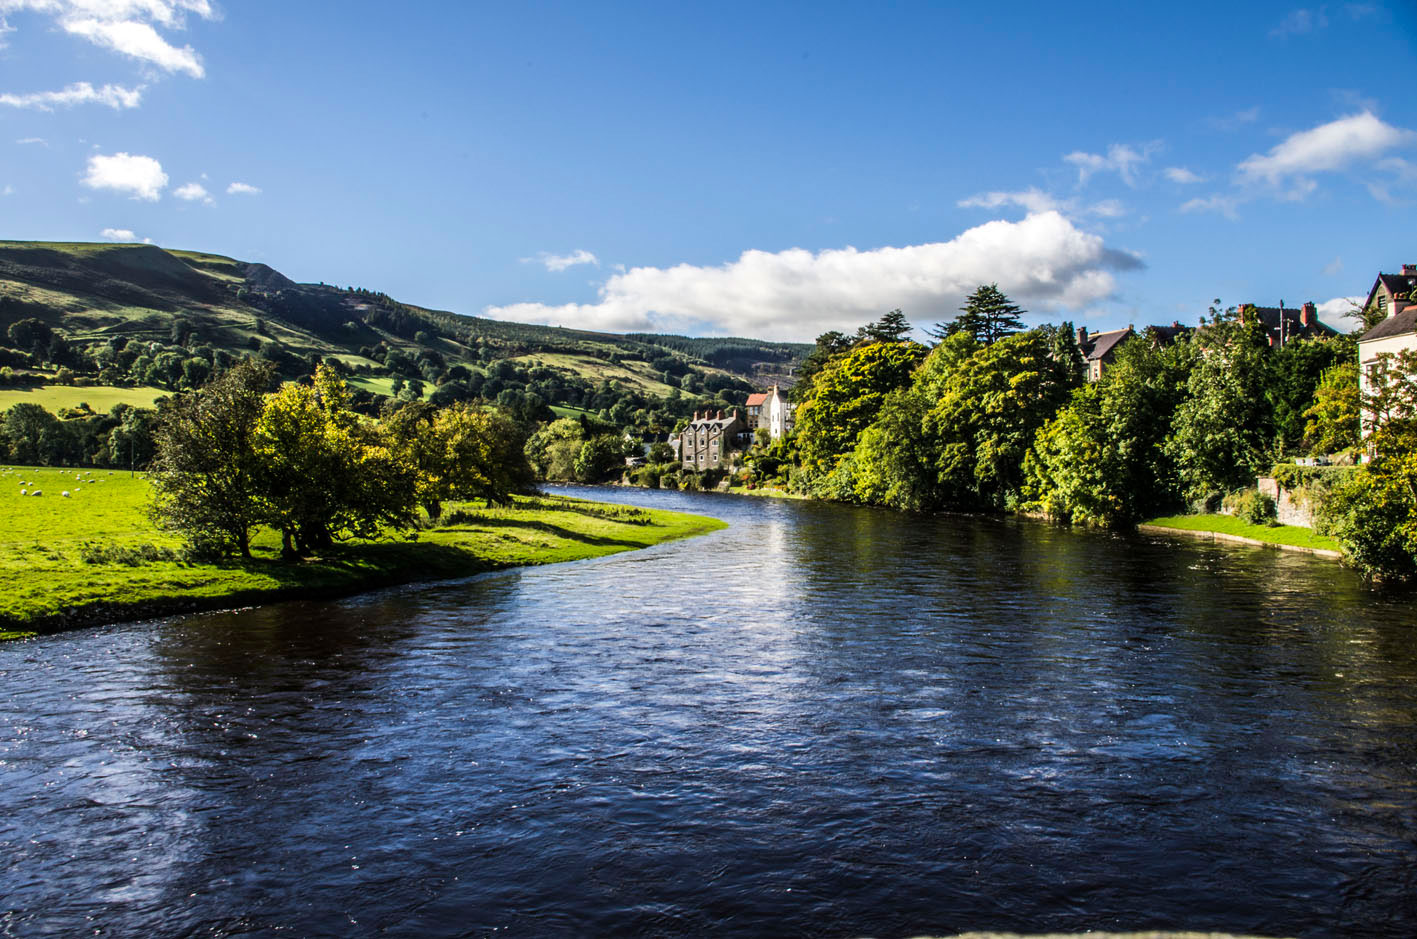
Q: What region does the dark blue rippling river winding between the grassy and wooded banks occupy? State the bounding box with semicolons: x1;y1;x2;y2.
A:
0;490;1417;938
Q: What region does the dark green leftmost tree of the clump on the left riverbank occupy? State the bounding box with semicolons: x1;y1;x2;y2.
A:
148;360;275;558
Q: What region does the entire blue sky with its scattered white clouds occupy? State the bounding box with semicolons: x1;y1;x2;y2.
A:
0;0;1417;340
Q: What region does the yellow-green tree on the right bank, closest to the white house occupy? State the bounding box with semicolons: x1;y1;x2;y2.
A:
796;343;925;476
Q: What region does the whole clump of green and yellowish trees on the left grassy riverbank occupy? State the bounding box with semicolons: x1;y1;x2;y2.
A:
152;361;531;558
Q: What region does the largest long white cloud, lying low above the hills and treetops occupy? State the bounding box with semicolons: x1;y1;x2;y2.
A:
485;211;1142;340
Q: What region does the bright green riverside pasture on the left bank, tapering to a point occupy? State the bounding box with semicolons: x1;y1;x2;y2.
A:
0;467;724;636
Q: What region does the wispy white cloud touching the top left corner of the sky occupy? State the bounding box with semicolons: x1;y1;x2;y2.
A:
0;0;217;78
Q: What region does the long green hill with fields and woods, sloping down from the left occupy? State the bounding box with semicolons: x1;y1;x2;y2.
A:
0;241;811;429
